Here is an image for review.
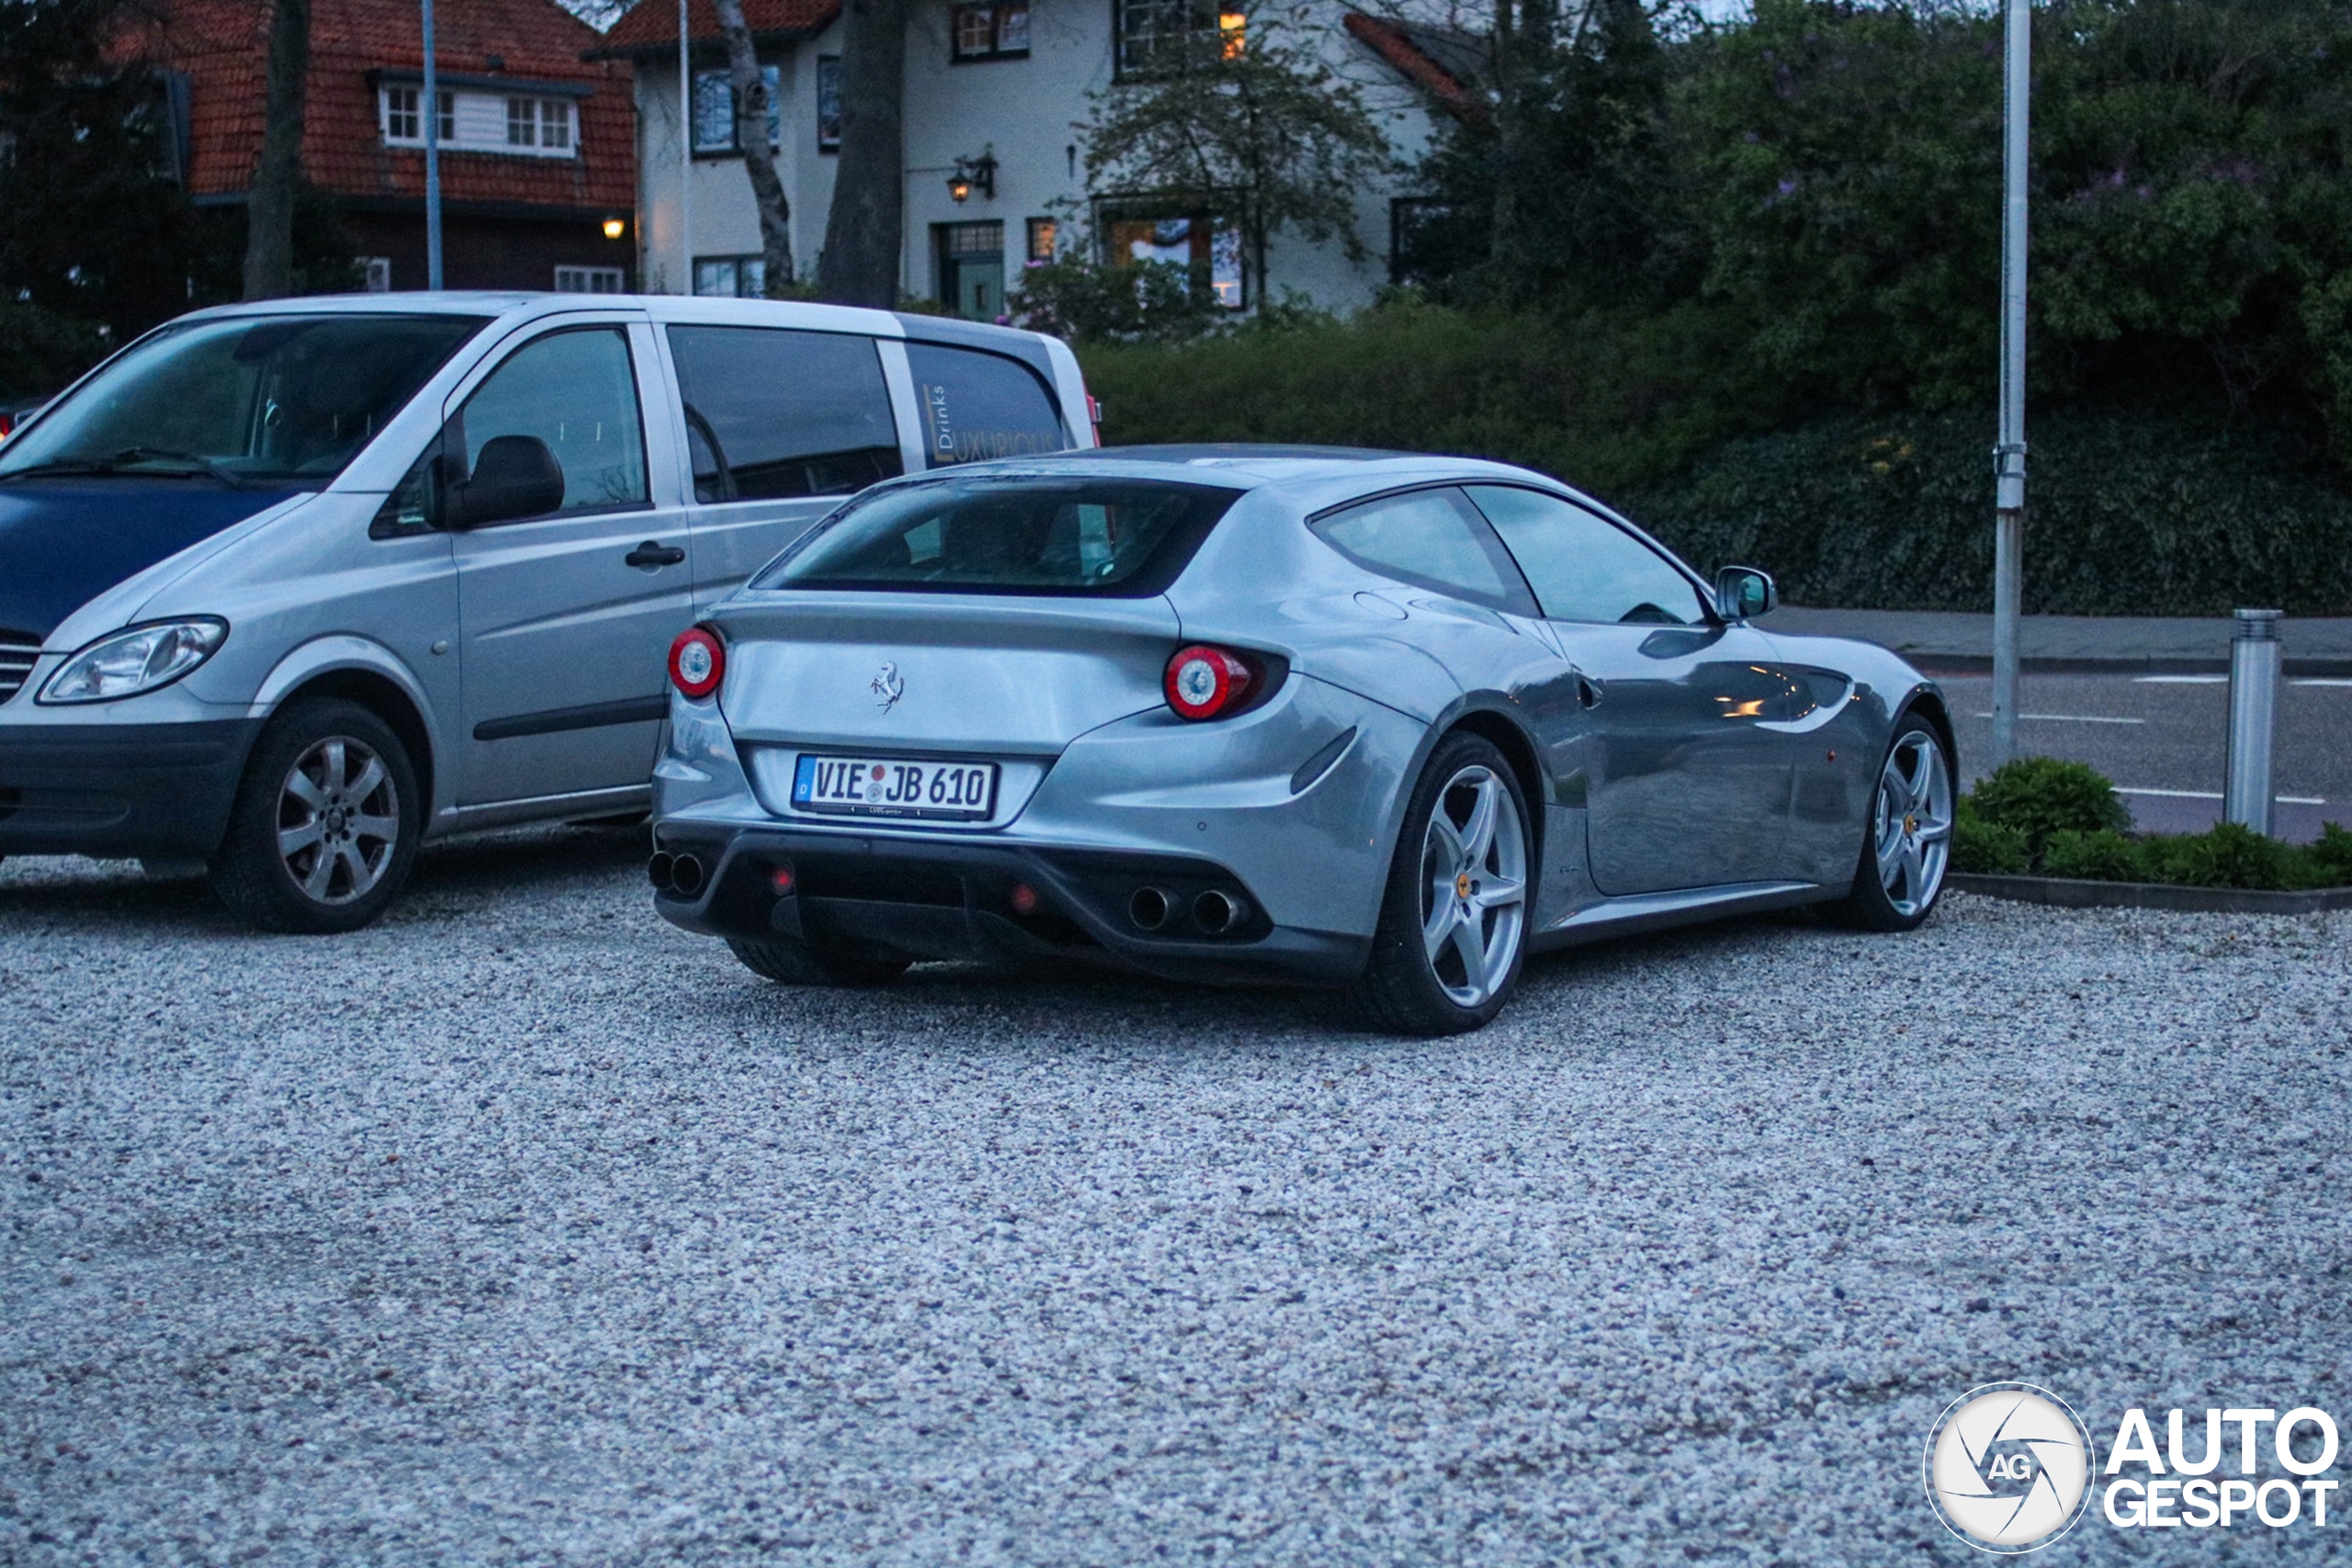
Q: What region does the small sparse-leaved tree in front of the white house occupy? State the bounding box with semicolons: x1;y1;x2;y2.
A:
1080;26;1393;299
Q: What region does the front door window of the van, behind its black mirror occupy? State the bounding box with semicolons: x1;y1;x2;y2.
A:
449;327;647;513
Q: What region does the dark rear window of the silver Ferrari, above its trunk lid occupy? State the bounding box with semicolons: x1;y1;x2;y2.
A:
752;478;1242;600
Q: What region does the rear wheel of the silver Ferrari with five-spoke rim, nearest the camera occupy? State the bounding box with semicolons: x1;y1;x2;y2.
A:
1350;733;1533;1034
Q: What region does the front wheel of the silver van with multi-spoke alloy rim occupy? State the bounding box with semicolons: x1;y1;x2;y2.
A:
211;698;424;936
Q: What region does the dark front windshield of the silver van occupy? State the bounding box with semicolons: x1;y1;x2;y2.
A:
0;315;489;484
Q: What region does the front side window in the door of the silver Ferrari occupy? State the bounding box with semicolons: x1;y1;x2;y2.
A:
1465;484;1708;626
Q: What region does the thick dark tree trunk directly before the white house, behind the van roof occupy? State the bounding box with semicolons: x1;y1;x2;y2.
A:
816;0;906;310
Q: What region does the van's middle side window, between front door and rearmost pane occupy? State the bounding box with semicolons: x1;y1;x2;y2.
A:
671;327;903;501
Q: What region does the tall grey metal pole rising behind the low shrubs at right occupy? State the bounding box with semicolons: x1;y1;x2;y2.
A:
1992;0;2032;766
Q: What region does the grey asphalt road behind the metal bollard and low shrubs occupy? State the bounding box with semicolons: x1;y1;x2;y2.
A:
1938;674;2352;840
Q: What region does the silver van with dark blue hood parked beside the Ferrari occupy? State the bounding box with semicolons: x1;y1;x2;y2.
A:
0;294;1096;931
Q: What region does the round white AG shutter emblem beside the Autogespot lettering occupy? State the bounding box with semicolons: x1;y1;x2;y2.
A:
1927;1382;2091;1551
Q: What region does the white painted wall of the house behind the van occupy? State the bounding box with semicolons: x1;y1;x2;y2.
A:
638;0;1430;310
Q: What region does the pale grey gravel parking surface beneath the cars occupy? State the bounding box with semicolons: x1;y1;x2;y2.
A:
0;829;2352;1565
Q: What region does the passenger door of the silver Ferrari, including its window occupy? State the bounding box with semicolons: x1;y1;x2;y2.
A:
1465;484;1792;896
